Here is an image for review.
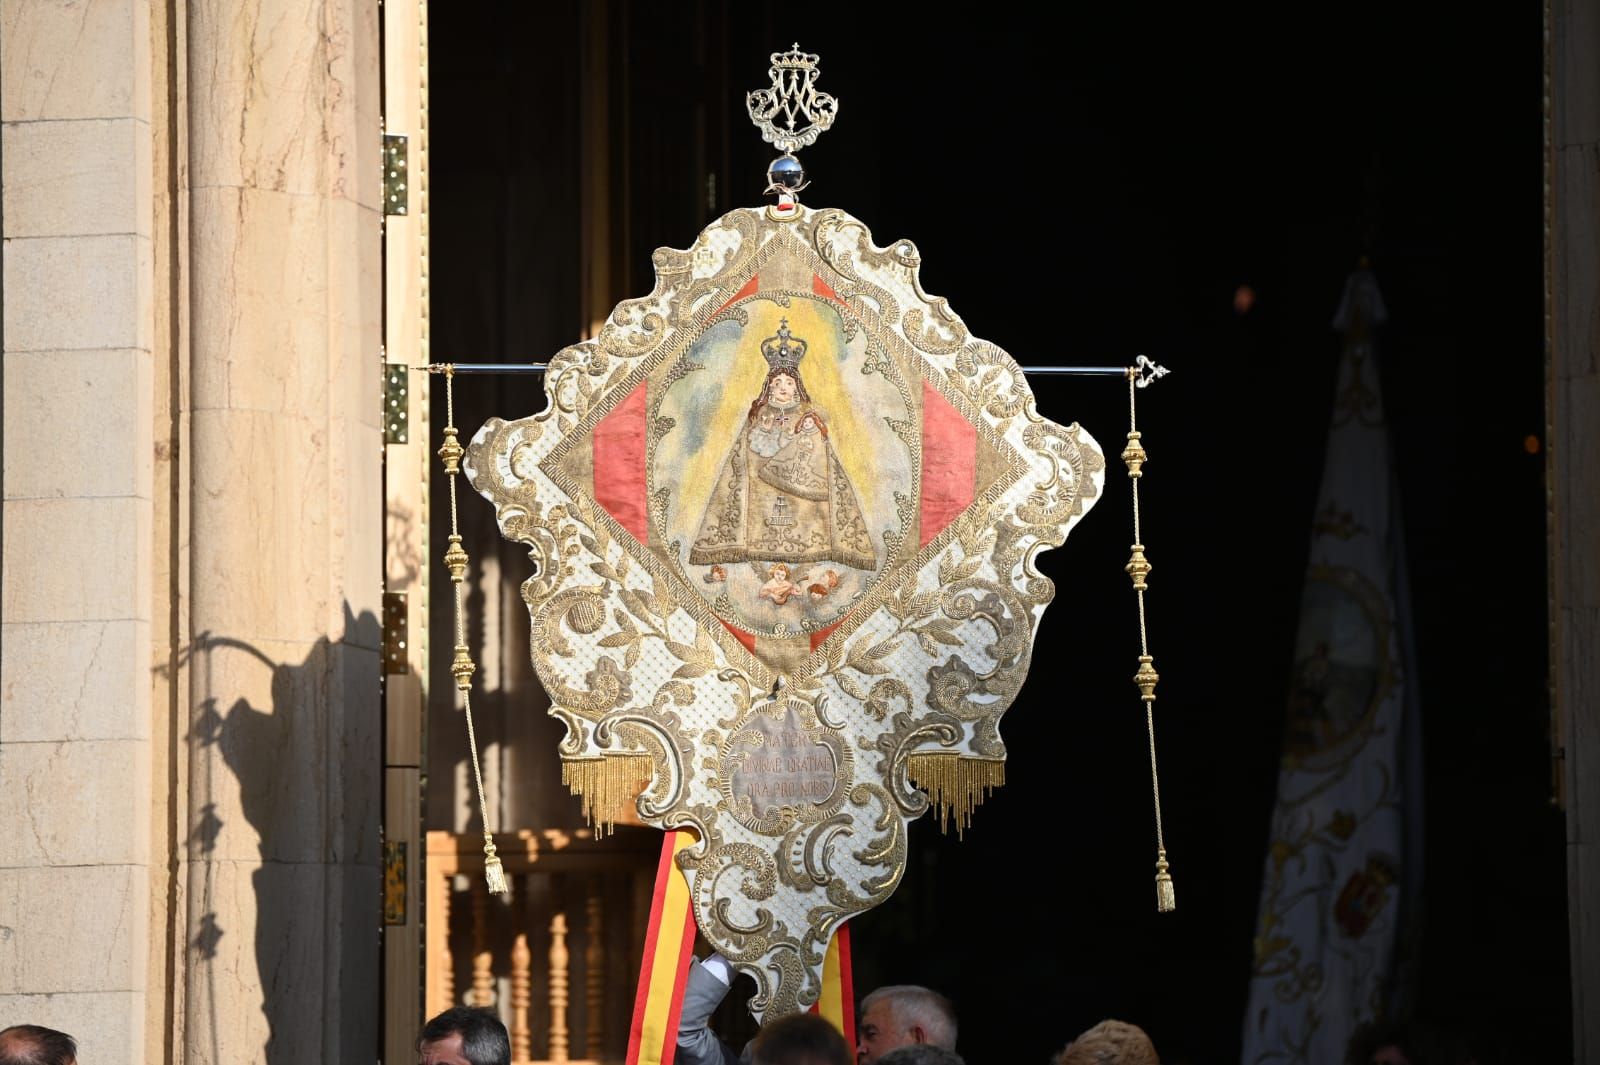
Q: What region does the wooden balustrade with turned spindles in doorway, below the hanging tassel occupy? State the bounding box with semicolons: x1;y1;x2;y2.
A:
424;825;661;1065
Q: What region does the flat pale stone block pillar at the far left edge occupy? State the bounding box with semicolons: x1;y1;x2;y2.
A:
0;0;163;1062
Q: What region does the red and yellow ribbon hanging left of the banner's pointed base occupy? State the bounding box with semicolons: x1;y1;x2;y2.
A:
627;830;694;1065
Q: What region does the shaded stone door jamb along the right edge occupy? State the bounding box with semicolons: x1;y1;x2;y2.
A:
1547;0;1600;1062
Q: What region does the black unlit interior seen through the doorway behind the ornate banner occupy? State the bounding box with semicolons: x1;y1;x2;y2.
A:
429;3;1571;1065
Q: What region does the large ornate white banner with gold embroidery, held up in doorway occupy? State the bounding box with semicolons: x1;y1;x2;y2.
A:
464;206;1104;1015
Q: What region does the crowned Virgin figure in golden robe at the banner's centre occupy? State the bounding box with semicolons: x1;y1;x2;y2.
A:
690;318;877;576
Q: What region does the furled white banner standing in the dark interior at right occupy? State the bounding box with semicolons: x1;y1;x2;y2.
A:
1242;265;1422;1065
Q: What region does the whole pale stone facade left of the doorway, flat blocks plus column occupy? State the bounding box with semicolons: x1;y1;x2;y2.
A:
0;0;382;1065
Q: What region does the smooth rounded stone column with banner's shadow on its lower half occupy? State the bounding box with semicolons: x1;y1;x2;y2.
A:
181;0;382;1065
